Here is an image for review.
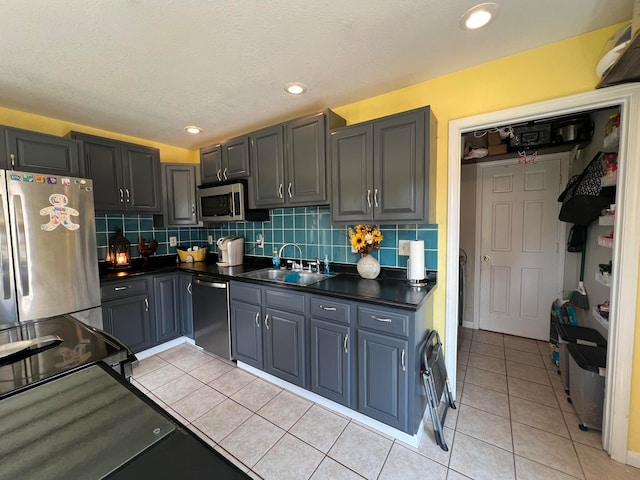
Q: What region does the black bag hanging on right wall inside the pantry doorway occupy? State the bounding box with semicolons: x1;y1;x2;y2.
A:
558;152;616;227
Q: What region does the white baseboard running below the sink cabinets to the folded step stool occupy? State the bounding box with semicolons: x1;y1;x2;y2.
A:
238;362;427;448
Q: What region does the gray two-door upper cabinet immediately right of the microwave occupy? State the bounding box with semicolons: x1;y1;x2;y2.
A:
249;110;345;208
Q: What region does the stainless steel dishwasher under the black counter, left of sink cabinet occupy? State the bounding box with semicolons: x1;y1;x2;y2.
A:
192;275;231;360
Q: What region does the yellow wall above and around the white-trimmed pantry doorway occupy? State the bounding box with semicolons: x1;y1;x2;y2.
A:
334;24;640;452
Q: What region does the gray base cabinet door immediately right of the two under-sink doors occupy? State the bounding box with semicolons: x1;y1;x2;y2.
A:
311;318;353;407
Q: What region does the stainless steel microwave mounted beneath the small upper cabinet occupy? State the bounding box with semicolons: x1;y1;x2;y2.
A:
198;181;269;223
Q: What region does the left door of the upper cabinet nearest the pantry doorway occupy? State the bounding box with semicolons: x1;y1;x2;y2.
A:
331;124;374;222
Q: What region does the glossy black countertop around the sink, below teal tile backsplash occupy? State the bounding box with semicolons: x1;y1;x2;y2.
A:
100;254;436;310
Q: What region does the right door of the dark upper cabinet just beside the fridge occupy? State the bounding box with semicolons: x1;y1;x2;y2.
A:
122;144;160;213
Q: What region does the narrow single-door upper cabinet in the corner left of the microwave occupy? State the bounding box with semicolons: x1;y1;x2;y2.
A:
162;164;201;227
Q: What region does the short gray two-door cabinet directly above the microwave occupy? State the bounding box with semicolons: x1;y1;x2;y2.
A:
200;135;249;183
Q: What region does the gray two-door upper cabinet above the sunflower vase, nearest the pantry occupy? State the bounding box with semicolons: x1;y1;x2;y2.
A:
331;107;436;223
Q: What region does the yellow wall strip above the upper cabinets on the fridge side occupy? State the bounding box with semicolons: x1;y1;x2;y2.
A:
0;107;200;163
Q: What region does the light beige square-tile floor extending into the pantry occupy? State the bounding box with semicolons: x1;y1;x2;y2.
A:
132;329;640;480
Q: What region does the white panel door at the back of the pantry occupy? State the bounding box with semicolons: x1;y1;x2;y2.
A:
479;160;560;340
